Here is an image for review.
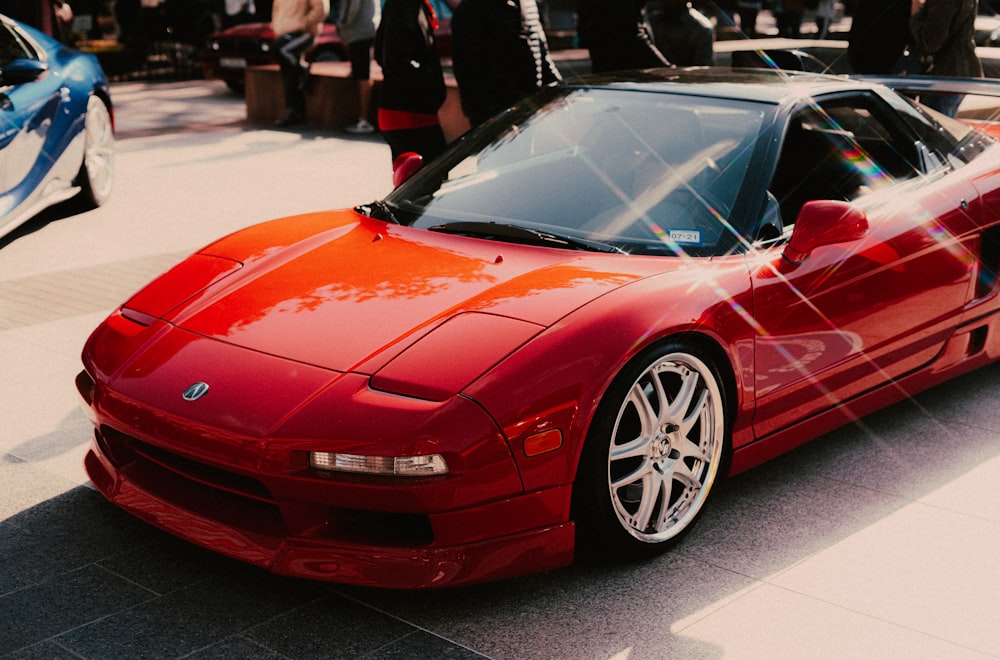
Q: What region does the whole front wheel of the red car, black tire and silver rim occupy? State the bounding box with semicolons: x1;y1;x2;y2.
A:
573;342;729;559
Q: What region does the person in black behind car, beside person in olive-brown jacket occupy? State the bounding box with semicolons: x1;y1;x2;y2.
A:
847;0;910;75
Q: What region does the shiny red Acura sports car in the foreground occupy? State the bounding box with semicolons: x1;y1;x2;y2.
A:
77;69;1000;588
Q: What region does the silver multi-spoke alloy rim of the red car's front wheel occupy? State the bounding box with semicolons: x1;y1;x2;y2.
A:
607;352;725;544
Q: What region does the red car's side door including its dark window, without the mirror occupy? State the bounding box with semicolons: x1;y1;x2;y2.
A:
753;94;979;437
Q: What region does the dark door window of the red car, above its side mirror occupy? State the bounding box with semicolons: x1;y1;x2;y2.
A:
769;97;920;227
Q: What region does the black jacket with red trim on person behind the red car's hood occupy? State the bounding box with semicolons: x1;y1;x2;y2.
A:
375;0;446;114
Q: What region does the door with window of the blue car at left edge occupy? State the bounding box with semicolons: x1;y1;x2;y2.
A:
0;22;61;203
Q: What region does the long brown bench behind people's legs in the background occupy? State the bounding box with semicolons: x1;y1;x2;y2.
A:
246;62;469;140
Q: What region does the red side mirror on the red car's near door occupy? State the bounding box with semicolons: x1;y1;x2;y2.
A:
781;199;868;264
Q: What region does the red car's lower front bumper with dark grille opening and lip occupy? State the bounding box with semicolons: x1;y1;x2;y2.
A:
85;400;574;589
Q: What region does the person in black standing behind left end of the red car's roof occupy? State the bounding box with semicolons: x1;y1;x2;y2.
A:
577;0;671;73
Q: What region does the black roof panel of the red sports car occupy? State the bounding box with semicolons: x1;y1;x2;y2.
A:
567;67;875;104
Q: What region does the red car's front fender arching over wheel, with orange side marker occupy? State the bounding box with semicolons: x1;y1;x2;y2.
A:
464;257;753;491
